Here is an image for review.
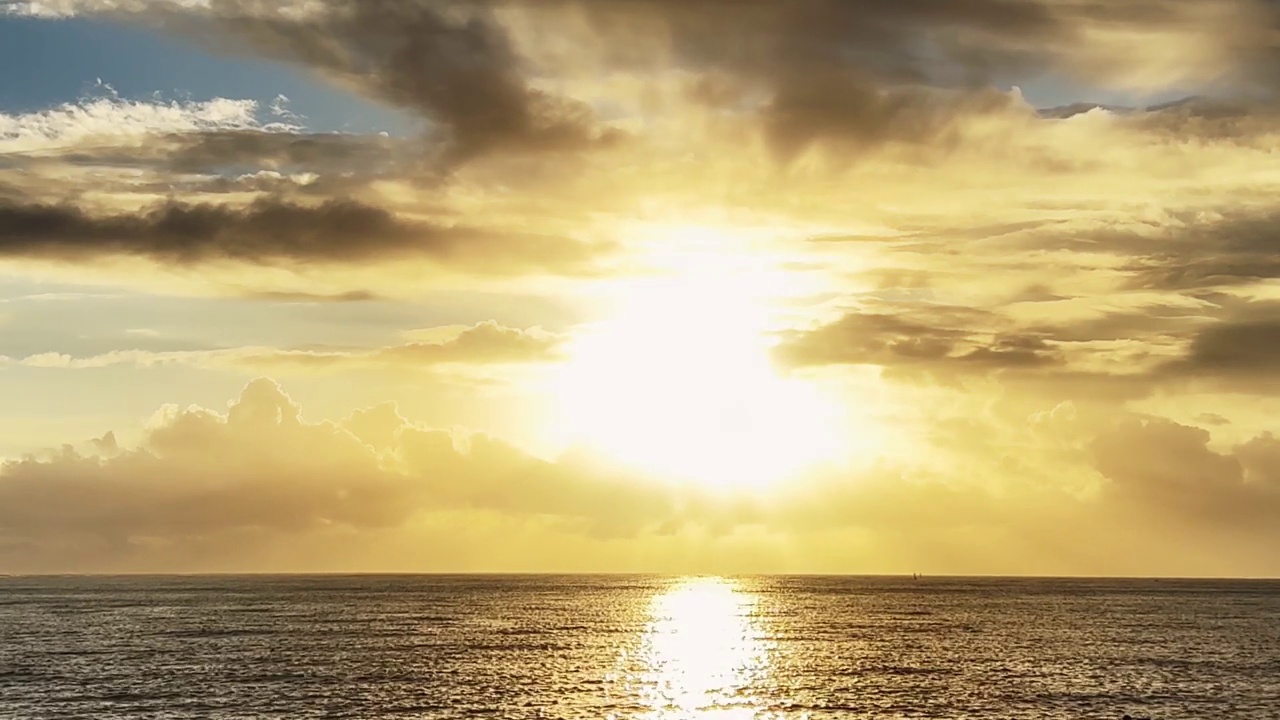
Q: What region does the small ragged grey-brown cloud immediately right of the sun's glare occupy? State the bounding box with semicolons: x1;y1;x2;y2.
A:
777;313;1061;373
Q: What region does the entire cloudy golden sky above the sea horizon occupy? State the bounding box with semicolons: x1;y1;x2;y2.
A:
0;0;1280;577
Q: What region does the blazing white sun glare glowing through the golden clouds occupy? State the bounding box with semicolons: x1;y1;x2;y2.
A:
558;220;841;488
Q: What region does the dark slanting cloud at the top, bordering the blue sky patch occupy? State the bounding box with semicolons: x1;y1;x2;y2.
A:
180;0;616;160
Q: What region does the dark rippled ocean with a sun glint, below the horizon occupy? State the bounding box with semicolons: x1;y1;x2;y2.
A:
0;575;1280;720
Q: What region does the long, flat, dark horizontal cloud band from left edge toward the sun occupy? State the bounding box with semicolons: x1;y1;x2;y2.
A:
0;199;604;274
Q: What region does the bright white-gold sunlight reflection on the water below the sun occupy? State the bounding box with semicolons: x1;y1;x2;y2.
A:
611;578;772;720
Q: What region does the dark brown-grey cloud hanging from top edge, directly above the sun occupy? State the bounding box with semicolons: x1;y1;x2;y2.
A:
584;0;1059;159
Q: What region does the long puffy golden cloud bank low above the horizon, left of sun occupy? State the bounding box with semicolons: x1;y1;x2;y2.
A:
0;379;676;565
